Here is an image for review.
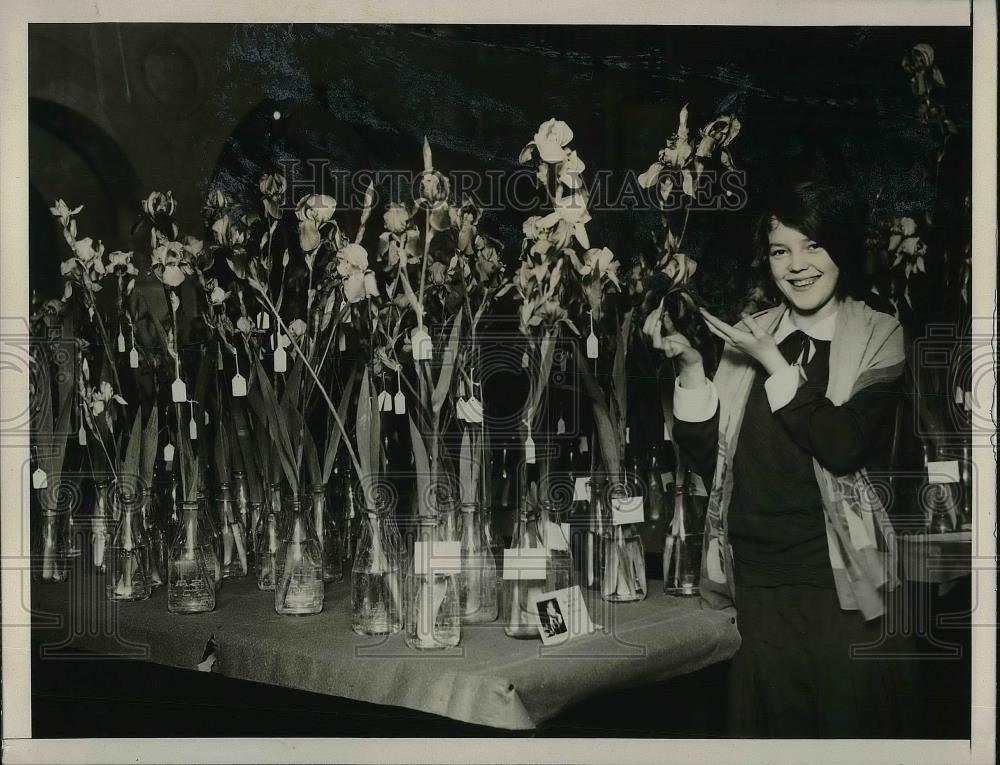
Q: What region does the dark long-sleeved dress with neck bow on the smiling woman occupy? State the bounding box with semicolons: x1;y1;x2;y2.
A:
674;331;910;738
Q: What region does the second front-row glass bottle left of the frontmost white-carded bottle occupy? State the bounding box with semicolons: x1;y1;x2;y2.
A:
274;494;323;616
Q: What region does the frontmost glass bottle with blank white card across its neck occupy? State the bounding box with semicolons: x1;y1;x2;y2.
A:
403;516;462;650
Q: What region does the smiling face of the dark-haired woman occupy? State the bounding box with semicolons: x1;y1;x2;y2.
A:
767;221;840;318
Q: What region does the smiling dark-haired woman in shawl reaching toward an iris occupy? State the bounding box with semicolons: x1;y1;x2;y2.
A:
644;183;910;738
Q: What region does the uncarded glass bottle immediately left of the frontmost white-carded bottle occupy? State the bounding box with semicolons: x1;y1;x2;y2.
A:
351;502;403;635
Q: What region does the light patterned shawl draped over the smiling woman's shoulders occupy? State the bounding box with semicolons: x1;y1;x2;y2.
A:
701;298;904;620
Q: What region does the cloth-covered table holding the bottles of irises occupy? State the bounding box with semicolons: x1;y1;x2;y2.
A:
32;571;740;730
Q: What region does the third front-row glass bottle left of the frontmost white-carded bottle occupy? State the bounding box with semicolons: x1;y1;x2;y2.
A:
167;501;217;614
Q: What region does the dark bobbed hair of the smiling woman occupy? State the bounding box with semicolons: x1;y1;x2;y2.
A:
753;181;868;299
